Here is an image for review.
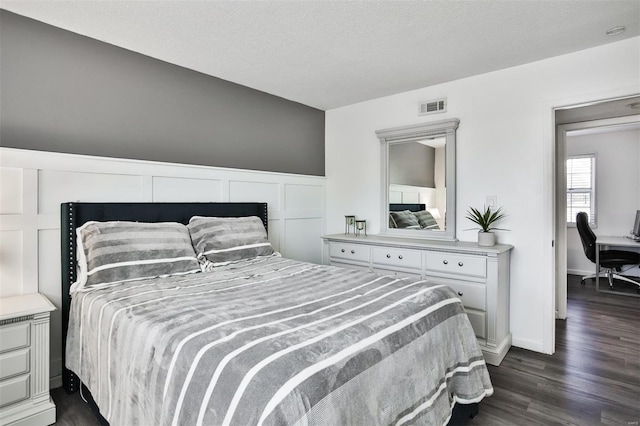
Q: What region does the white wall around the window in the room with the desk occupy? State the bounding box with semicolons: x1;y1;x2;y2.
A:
567;129;640;276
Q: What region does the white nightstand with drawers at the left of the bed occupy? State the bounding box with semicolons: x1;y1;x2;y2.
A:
0;293;56;426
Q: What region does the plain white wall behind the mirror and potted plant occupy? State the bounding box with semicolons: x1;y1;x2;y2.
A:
325;37;640;352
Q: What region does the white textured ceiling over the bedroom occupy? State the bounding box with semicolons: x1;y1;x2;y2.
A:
0;0;640;110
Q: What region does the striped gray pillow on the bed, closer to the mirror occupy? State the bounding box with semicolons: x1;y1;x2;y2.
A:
187;216;273;266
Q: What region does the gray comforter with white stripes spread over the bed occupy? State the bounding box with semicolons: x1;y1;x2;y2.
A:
66;256;493;425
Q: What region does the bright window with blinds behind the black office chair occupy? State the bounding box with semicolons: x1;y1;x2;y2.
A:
566;154;596;226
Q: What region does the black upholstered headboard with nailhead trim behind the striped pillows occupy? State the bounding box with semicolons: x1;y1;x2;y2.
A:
60;203;268;392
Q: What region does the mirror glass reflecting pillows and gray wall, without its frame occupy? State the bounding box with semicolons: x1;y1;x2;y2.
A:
388;137;447;231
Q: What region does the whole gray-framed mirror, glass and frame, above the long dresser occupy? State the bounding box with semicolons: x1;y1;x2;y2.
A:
376;118;460;241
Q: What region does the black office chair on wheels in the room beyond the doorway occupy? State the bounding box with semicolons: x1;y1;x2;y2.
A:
576;212;640;292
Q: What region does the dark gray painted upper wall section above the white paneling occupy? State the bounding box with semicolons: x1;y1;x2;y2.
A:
0;10;325;176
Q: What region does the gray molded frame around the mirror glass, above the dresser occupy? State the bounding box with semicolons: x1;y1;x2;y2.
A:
376;118;460;241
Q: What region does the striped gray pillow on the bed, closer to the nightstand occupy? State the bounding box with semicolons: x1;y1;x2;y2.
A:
71;222;200;292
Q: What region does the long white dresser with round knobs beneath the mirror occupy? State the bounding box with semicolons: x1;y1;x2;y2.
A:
322;234;513;365
